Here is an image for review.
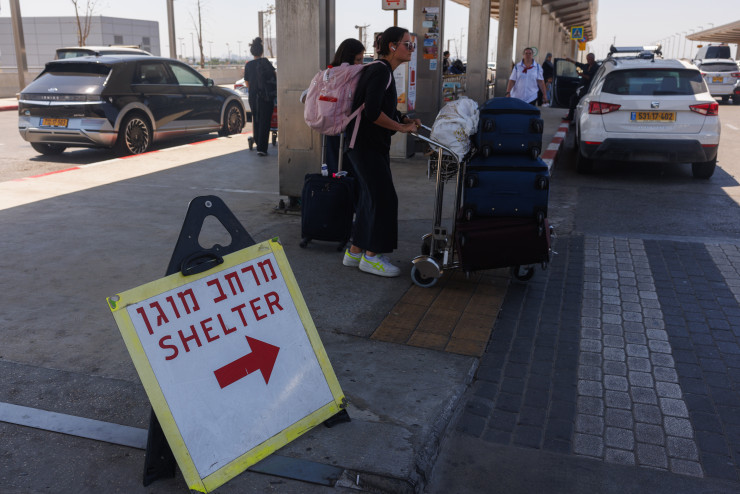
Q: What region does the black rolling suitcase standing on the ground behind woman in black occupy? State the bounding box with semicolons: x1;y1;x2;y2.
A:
300;135;355;250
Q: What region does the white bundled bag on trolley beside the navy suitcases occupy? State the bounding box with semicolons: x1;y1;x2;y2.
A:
429;96;479;160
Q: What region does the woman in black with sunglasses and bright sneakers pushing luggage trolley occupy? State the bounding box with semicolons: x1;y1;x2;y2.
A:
342;27;421;277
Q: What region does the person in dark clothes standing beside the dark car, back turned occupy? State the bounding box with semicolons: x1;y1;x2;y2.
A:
244;37;277;156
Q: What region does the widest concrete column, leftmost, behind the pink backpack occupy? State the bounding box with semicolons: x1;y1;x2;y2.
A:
270;0;336;201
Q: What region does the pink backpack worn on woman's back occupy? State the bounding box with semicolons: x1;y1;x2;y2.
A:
303;60;393;148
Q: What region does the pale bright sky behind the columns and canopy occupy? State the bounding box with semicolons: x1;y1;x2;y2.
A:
0;0;740;59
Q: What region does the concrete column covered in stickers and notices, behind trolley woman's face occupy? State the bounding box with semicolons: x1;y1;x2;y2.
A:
410;0;446;126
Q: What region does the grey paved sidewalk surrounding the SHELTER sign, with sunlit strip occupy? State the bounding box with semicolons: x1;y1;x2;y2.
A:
0;105;572;493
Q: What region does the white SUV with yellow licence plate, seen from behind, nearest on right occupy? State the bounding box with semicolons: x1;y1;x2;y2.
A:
575;58;720;178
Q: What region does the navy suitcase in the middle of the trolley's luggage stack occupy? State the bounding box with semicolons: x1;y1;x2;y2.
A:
461;155;550;221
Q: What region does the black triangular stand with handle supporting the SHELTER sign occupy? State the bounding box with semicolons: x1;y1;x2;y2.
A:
143;196;256;486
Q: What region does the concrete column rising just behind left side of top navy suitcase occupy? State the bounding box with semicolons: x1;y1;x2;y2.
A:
465;0;491;104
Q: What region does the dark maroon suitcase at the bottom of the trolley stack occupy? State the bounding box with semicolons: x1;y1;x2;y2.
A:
455;217;550;271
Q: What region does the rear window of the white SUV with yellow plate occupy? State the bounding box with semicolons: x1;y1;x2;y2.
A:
602;69;707;96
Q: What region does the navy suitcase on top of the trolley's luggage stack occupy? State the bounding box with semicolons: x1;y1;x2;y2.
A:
475;98;544;159
